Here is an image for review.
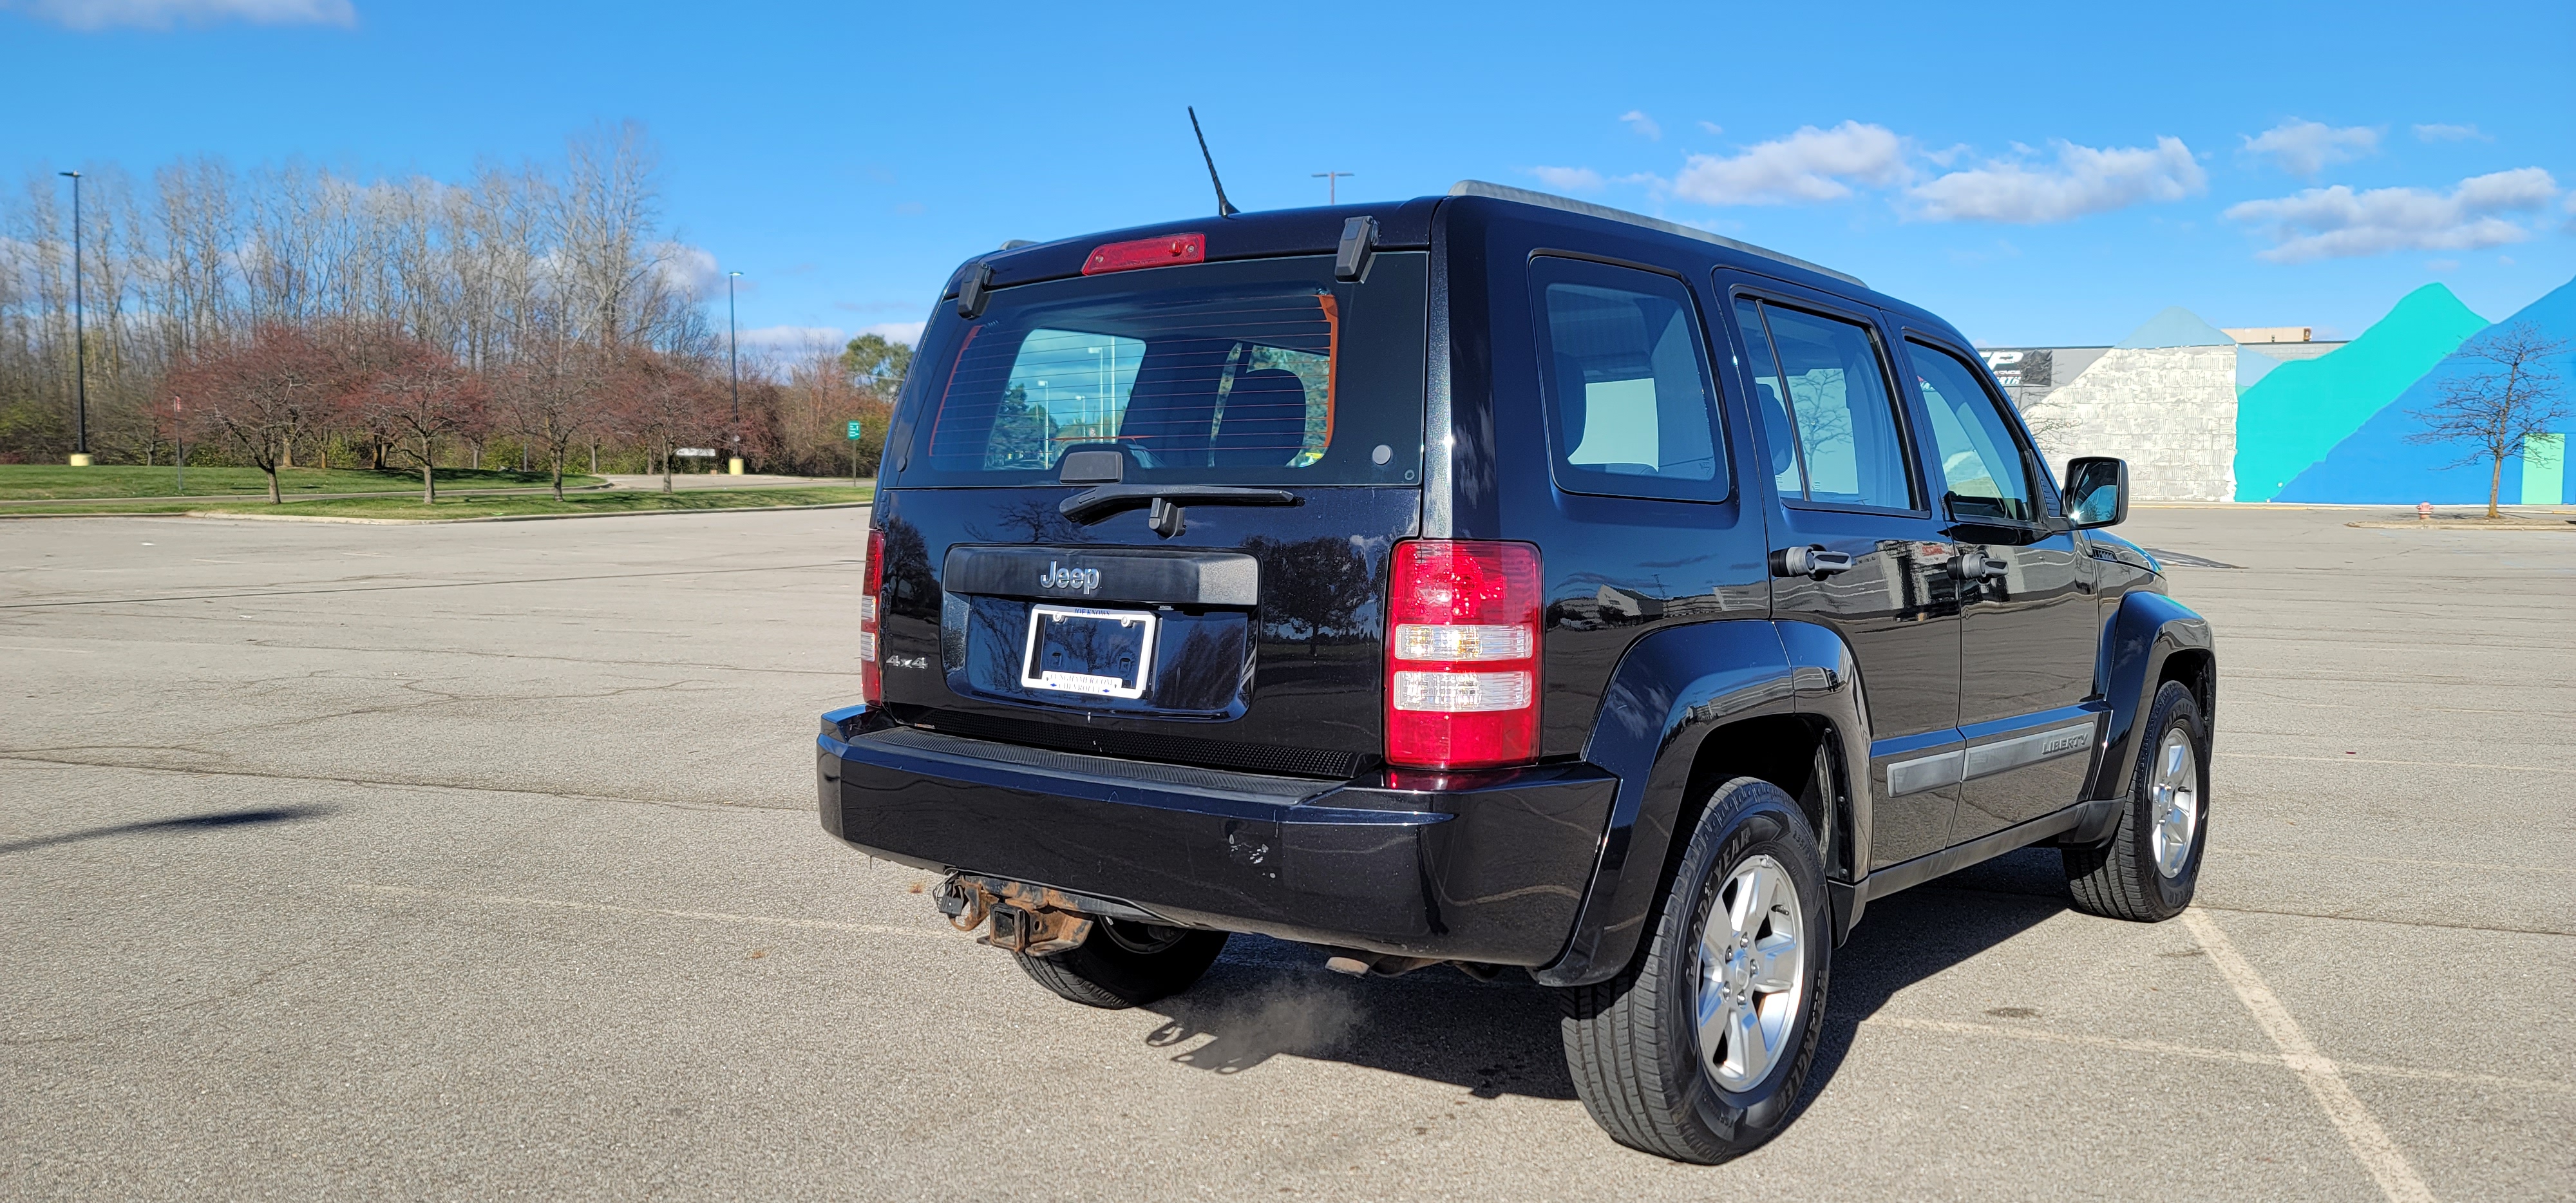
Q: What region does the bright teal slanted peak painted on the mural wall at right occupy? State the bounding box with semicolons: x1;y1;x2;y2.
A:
2236;283;2486;502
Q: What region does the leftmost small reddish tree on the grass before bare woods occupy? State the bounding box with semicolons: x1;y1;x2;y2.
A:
165;327;340;505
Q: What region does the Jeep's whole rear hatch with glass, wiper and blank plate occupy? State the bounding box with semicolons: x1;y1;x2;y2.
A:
876;252;1427;778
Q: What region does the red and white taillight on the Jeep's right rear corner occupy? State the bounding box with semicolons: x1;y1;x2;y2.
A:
1386;538;1538;768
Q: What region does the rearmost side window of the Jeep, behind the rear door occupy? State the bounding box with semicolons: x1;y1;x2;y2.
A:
1530;258;1734;502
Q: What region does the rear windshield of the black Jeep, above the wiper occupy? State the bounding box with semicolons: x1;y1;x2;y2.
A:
902;252;1427;484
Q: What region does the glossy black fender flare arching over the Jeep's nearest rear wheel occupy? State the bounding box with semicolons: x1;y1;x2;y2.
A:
1530;618;1870;987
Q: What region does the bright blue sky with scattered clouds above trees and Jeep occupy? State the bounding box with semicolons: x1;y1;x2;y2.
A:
0;0;2576;345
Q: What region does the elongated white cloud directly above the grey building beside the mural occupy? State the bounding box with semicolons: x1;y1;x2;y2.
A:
1906;137;2210;224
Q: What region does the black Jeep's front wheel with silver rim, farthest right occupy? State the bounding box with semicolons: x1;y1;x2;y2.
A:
2061;680;2210;922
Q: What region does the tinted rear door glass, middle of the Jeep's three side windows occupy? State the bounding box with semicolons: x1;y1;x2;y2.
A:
1739;301;1917;510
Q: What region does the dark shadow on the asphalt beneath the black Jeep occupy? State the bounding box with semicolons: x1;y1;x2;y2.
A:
1144;848;2066;1100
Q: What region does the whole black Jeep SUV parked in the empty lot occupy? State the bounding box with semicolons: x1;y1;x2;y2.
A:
819;183;2218;1162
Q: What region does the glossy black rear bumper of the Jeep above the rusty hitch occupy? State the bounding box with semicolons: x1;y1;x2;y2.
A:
817;726;1618;966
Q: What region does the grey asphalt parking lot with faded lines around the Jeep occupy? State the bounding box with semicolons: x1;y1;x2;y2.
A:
0;507;2576;1200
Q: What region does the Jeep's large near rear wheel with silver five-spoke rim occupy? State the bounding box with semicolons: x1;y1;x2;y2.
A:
1558;778;1834;1164
